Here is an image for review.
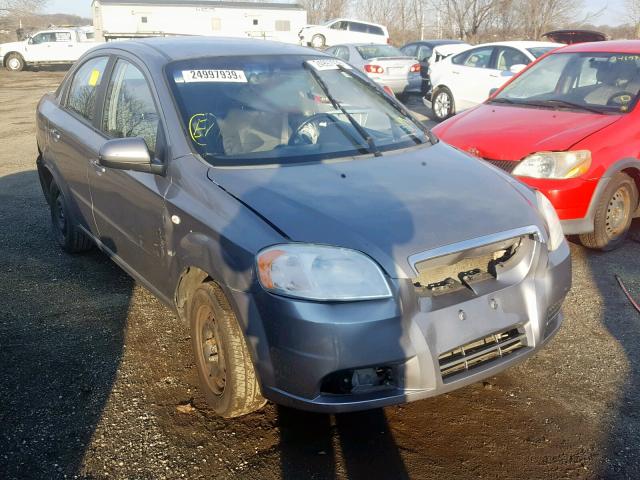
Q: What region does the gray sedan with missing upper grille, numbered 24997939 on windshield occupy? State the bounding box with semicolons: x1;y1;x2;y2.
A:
37;37;571;417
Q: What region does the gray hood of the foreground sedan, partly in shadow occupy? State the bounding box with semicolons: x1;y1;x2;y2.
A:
208;143;540;278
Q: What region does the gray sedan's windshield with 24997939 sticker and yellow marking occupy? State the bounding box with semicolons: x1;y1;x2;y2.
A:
167;55;429;165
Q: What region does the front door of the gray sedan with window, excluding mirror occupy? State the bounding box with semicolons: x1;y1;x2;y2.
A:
89;59;169;287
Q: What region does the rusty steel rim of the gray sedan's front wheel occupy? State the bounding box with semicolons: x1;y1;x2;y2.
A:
197;305;227;395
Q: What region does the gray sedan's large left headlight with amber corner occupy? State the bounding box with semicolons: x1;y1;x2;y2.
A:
257;243;391;301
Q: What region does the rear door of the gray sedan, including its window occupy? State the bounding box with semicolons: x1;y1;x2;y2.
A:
47;55;109;233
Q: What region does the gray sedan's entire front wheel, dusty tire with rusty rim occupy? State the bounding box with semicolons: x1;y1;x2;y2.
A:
189;282;266;418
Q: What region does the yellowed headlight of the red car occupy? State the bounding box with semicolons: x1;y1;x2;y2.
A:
513;150;591;178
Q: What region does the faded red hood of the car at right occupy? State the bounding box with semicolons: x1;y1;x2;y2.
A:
433;104;621;160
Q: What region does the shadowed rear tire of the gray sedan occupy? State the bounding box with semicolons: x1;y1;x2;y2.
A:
49;182;93;253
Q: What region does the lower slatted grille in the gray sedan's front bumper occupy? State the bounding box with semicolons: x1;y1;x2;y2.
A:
438;328;527;380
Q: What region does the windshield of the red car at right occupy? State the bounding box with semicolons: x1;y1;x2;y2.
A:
491;52;640;113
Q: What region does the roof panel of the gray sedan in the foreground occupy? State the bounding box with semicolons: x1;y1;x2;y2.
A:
87;36;325;63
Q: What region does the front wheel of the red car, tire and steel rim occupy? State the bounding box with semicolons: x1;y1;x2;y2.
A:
580;172;638;251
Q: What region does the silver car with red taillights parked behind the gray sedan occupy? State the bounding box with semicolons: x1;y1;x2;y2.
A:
325;43;422;96
